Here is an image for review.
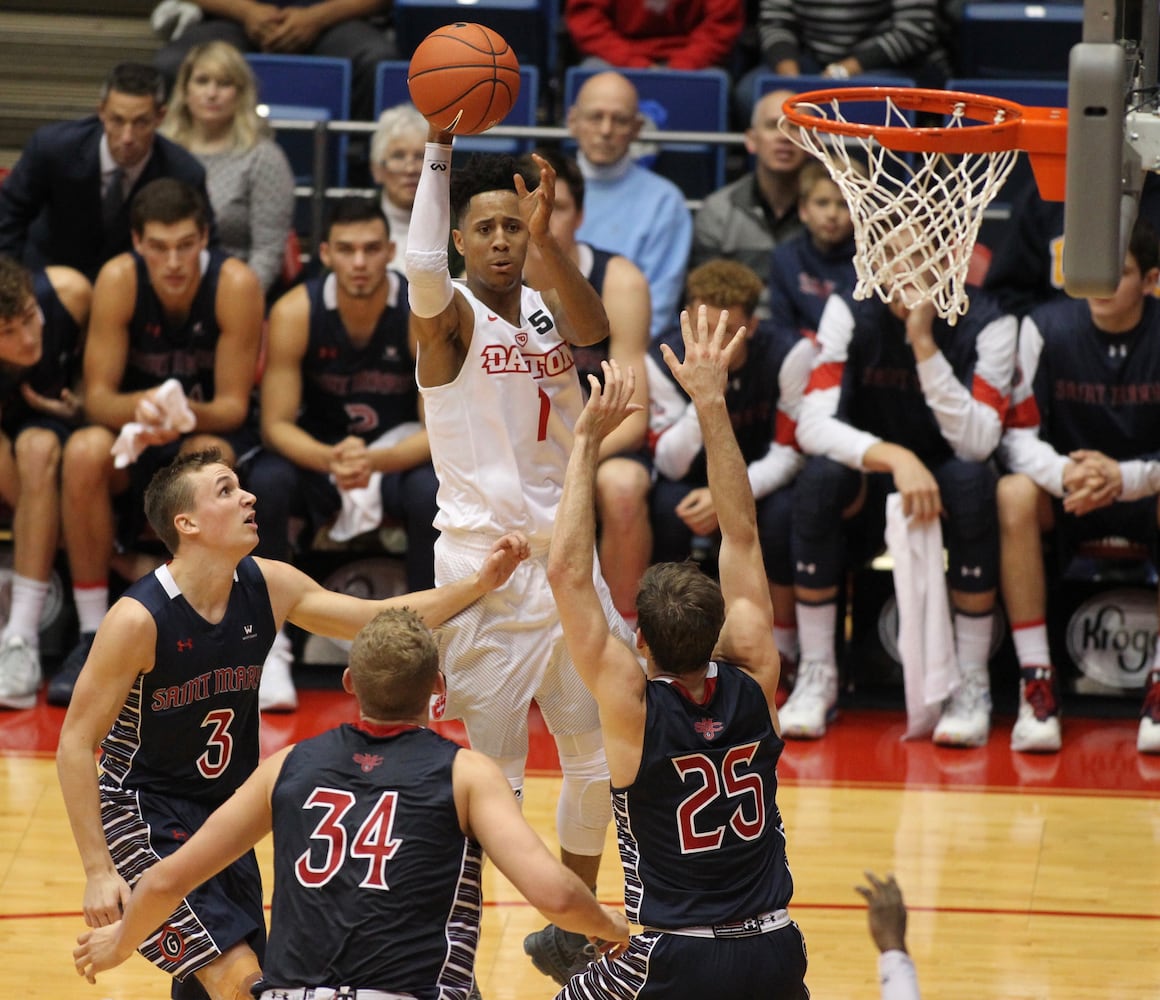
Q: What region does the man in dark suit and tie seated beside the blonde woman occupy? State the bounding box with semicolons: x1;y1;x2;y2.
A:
0;63;217;281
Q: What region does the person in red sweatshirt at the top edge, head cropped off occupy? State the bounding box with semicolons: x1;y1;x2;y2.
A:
564;0;745;70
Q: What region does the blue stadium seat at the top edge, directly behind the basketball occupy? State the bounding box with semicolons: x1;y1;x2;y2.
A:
394;0;563;85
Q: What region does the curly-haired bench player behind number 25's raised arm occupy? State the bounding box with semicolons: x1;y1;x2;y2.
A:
648;260;814;682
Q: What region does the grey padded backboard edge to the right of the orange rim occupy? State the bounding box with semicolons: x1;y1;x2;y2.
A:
1064;0;1160;296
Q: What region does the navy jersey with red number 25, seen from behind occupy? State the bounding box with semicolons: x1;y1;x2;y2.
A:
612;662;793;929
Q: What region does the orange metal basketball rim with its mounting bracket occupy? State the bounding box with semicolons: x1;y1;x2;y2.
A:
782;87;1067;202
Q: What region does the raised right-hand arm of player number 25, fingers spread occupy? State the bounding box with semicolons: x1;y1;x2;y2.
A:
661;306;781;725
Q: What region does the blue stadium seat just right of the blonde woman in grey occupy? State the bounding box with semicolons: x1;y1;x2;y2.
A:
246;53;350;187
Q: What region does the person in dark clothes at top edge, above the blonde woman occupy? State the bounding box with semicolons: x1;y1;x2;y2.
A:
153;0;399;122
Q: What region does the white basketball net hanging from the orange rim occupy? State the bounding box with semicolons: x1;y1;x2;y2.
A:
781;97;1018;324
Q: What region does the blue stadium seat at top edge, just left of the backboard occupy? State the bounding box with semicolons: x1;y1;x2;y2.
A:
958;2;1083;80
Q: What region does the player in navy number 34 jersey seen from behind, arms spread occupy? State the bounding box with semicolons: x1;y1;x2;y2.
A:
74;608;629;997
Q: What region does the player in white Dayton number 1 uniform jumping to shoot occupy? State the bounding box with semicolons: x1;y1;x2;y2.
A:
406;126;630;984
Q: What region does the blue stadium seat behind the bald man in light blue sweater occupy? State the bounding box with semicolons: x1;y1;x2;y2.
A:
564;66;731;198
